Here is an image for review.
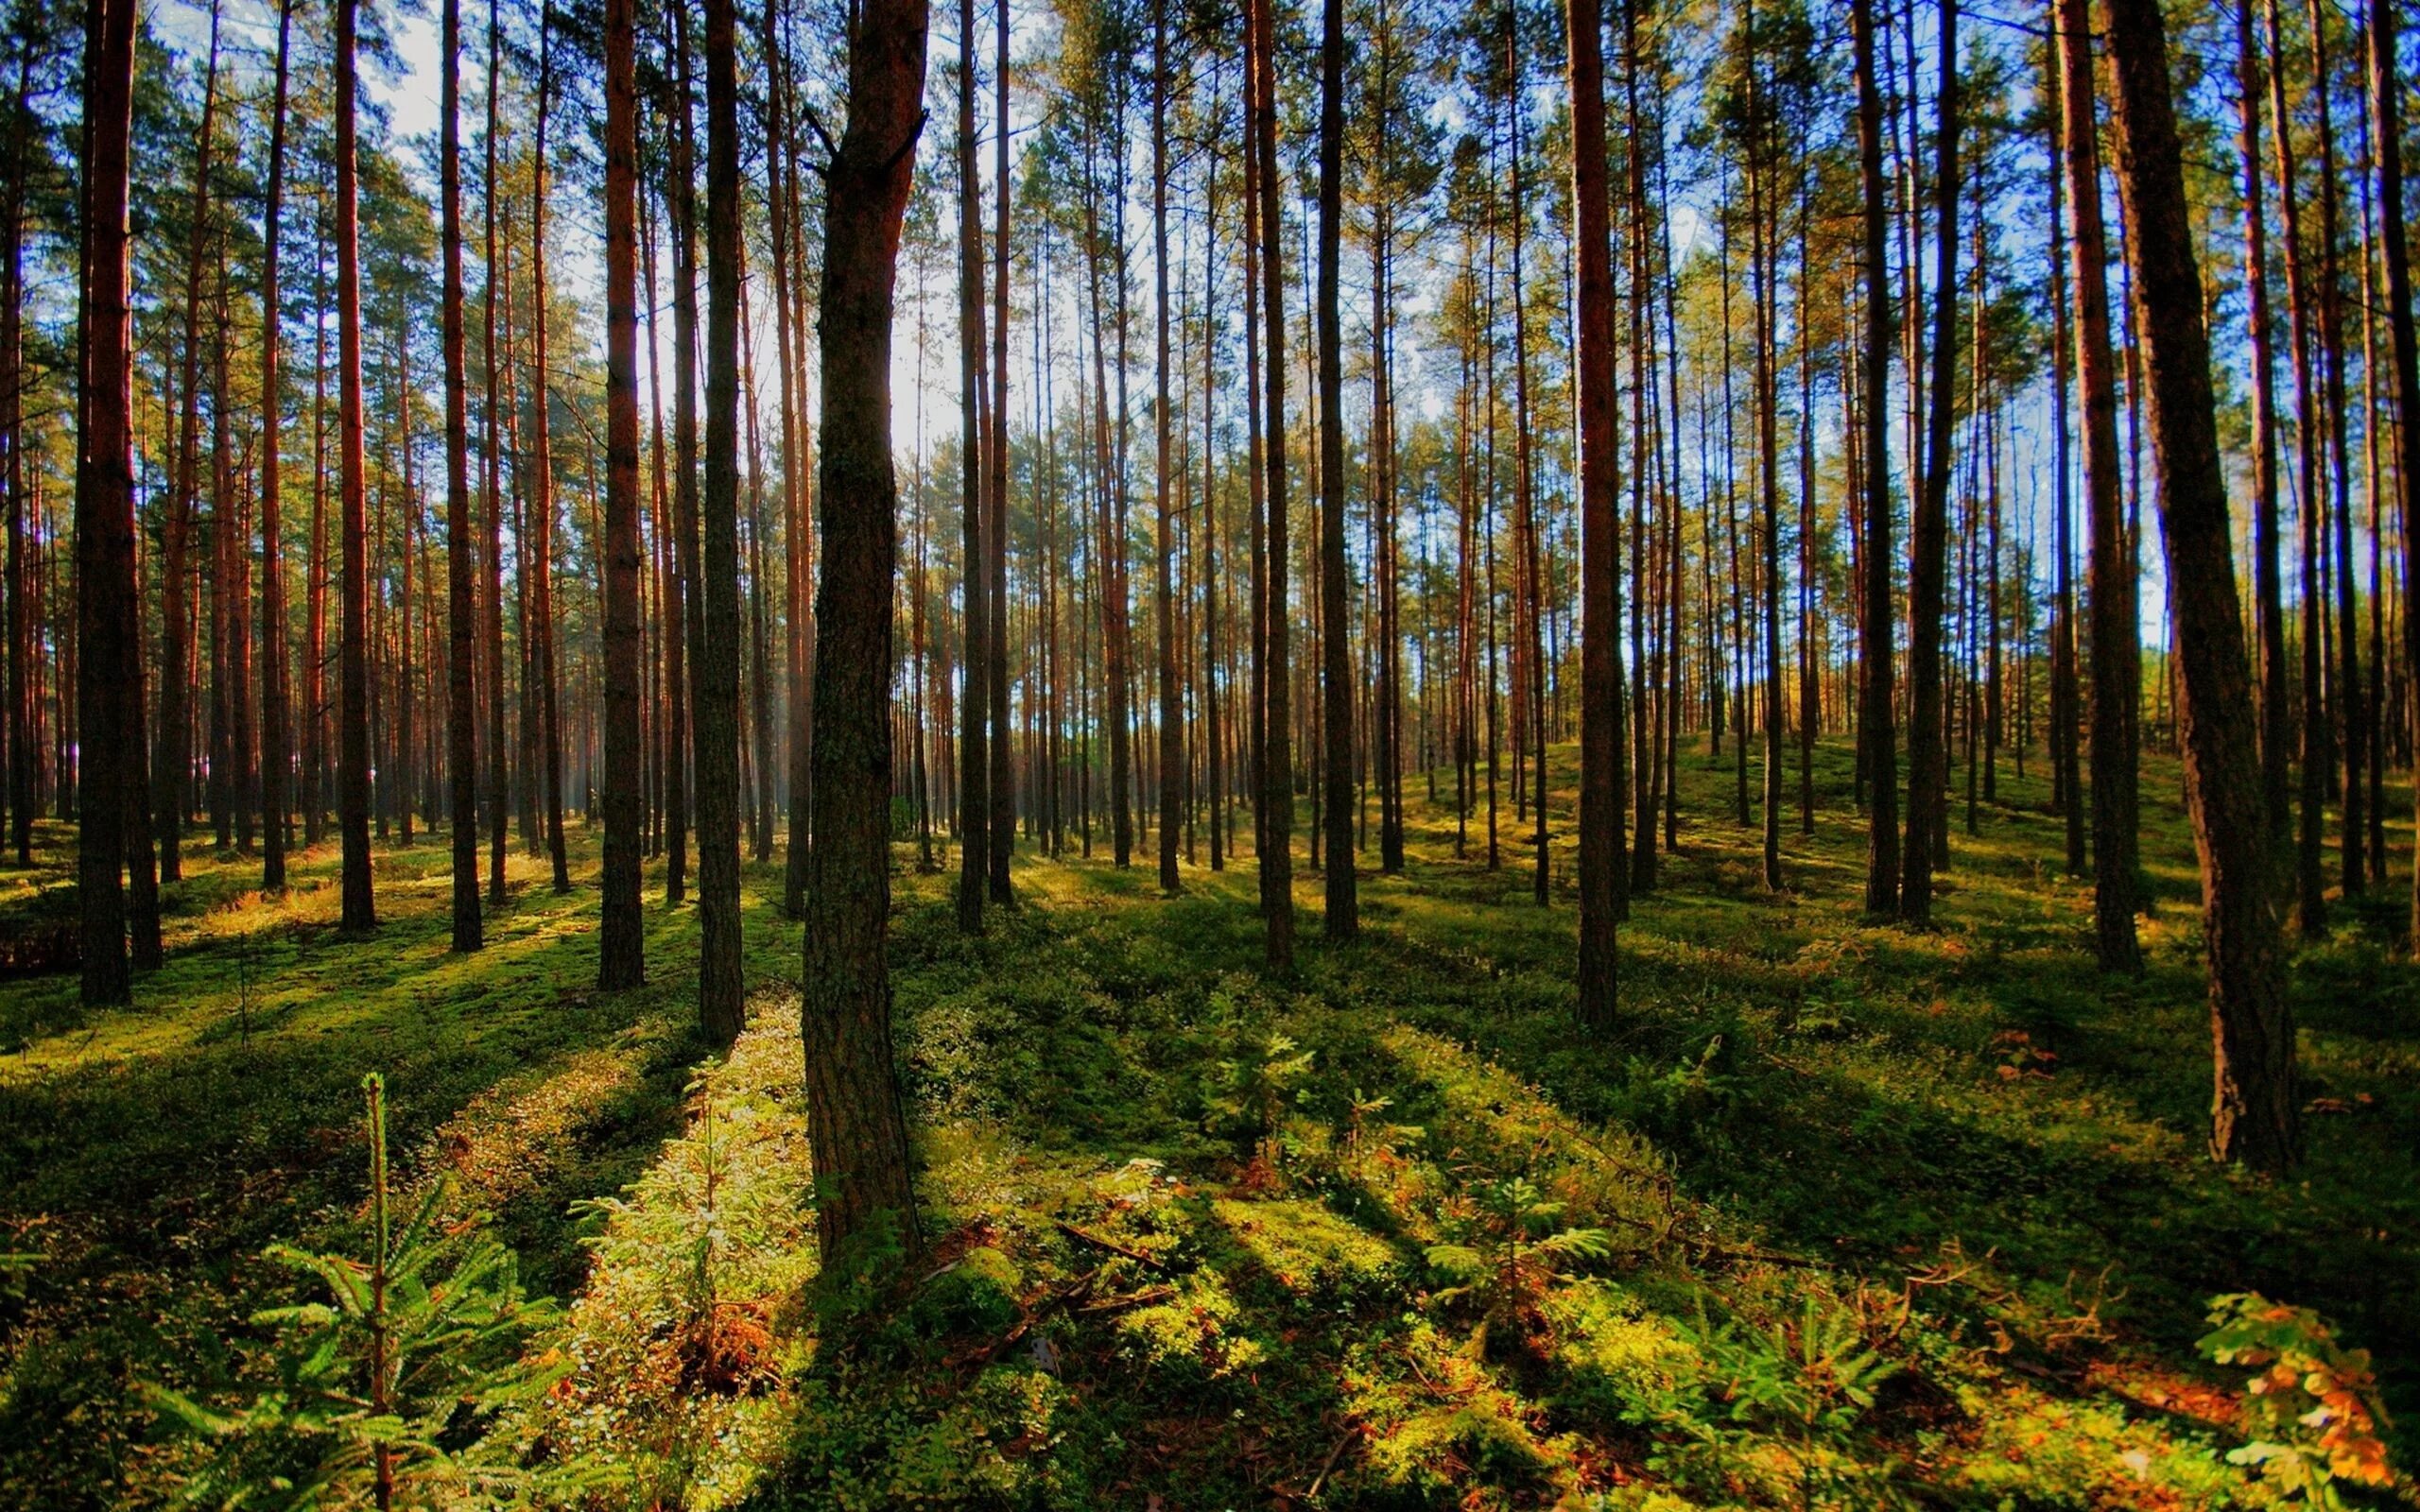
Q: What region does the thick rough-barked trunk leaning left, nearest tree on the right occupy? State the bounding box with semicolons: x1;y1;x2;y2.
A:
2108;0;2302;1168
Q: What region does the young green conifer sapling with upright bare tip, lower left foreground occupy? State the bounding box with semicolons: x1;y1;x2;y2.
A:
146;1072;559;1509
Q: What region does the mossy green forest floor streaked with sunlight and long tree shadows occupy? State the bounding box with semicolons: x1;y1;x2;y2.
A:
0;738;2420;1509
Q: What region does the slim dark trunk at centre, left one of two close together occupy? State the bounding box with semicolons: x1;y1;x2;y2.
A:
1246;0;1295;972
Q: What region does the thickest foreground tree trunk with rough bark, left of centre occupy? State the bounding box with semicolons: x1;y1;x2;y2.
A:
808;0;926;1273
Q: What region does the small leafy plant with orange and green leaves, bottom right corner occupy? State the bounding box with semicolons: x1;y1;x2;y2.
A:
2197;1292;2395;1507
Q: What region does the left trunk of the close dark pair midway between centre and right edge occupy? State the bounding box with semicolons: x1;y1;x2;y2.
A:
1849;0;1900;917
